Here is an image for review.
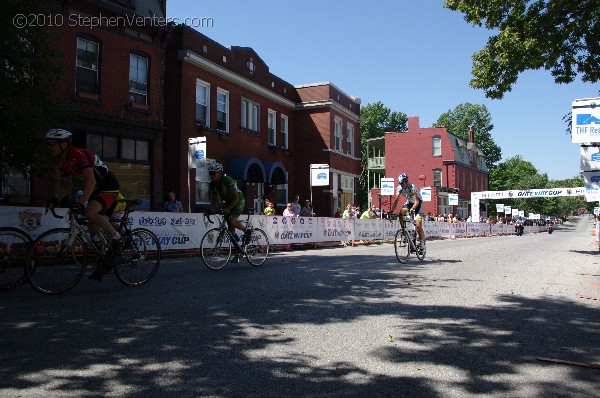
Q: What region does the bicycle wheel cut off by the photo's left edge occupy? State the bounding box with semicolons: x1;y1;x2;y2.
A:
0;227;33;290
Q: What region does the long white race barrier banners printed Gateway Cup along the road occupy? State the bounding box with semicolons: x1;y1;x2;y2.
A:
0;206;546;250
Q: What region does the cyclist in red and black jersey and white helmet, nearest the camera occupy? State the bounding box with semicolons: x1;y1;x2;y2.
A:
45;129;121;280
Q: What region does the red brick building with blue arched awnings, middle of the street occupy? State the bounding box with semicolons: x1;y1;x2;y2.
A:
164;25;360;215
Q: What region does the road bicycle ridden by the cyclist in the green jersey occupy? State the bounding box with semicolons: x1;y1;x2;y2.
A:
200;209;269;270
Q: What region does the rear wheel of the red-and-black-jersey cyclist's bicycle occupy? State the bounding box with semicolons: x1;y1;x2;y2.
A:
115;228;161;286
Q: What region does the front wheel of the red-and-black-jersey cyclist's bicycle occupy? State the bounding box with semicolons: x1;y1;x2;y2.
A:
25;228;87;295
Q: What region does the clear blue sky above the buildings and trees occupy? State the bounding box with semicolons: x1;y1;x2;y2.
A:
167;0;600;180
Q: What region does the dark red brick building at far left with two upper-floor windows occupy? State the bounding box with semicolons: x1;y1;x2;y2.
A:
31;0;168;209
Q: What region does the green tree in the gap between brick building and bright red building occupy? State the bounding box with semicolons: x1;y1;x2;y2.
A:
358;101;408;209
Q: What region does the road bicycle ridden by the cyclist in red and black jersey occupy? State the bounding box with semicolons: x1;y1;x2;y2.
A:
25;200;161;295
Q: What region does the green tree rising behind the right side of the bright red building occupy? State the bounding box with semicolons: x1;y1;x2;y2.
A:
434;102;502;170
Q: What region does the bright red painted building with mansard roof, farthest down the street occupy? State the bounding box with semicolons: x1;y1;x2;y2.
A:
369;117;488;219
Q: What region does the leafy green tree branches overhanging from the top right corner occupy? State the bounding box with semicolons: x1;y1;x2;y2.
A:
444;0;600;99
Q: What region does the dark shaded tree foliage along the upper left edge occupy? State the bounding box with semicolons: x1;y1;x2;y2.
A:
0;0;71;178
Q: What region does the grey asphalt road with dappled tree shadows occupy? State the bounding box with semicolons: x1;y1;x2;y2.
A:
0;216;600;398
